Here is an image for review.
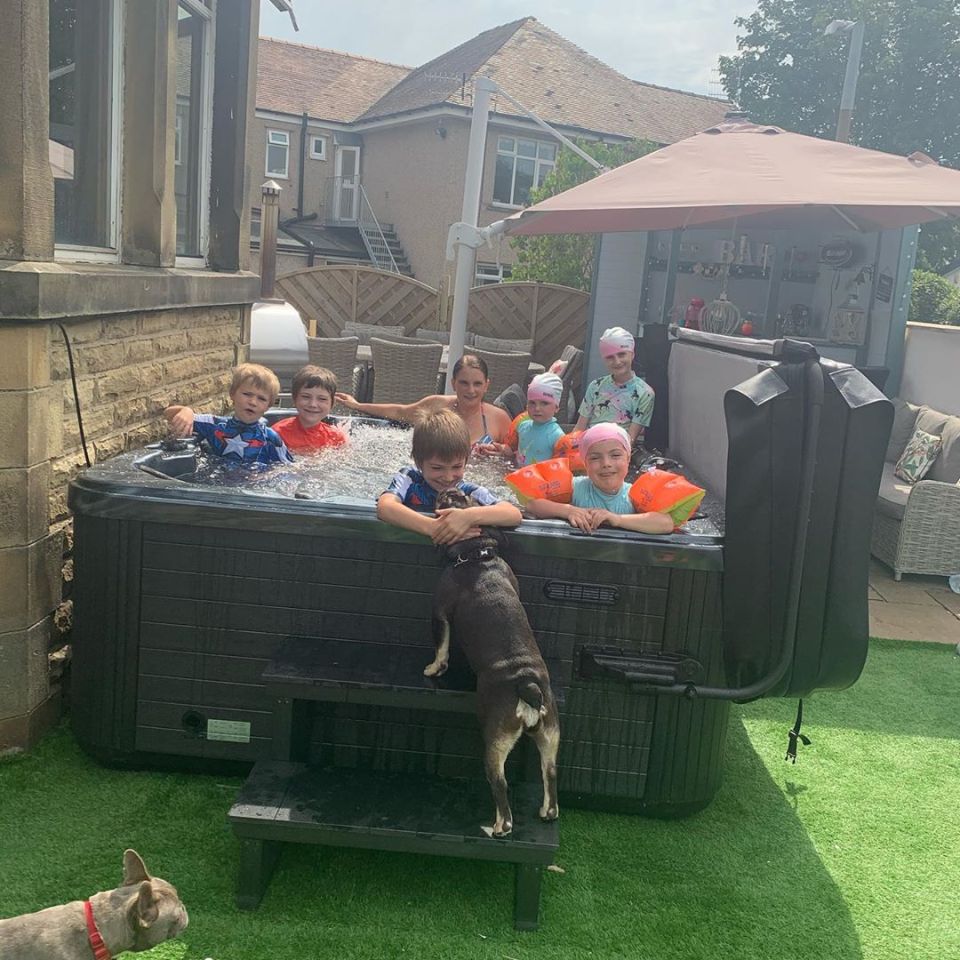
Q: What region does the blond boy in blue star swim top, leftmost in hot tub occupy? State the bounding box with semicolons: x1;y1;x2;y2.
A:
163;363;293;464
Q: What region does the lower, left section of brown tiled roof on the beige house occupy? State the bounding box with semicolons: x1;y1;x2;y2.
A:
257;37;410;123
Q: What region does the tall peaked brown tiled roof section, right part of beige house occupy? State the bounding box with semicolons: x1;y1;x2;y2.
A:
357;17;729;144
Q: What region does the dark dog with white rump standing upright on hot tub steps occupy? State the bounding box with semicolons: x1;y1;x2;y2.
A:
423;490;560;837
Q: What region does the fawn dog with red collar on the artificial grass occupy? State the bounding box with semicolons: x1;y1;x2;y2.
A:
0;850;187;960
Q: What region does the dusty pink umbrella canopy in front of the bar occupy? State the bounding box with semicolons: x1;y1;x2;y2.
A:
507;121;960;235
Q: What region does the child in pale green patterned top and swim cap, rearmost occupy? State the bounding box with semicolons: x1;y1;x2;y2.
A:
574;327;654;444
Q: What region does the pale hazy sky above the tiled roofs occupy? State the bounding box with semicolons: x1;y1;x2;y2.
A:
260;0;756;96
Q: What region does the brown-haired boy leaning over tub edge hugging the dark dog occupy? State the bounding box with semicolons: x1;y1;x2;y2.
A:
377;410;522;544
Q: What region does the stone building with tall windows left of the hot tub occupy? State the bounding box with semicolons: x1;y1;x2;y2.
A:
0;0;289;750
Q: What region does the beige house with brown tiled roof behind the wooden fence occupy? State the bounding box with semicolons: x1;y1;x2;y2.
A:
248;17;728;286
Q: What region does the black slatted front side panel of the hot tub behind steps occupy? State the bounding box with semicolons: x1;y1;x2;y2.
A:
74;506;726;812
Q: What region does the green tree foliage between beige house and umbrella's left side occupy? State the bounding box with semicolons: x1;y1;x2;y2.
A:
510;140;657;290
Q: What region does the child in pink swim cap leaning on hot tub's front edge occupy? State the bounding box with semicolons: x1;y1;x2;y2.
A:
526;423;674;533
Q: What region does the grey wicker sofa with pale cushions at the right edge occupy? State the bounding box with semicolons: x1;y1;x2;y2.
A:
870;400;960;580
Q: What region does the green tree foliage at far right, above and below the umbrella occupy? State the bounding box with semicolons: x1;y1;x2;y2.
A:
720;0;960;270
